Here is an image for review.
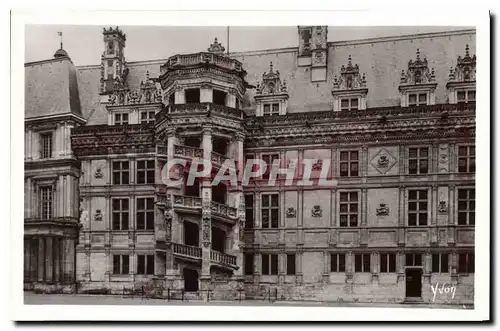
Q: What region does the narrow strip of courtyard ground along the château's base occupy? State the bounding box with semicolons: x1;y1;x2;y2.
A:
24;292;472;309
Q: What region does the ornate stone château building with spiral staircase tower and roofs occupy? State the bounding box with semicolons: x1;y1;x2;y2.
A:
24;26;476;303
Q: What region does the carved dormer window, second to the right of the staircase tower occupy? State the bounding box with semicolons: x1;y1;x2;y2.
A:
332;55;368;111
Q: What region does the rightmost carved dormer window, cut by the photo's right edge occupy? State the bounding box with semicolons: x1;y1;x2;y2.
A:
446;45;476;104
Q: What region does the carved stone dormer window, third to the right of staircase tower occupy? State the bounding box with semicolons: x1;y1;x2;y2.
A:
399;49;437;107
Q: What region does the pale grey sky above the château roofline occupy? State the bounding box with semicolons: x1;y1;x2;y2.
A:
25;25;472;66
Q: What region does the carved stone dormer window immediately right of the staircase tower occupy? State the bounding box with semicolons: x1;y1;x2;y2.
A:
255;62;288;116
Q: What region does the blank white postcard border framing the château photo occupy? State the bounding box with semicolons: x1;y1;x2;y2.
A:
9;9;490;321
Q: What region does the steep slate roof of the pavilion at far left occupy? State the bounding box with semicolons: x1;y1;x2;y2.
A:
24;57;82;118
